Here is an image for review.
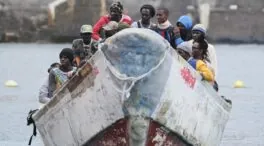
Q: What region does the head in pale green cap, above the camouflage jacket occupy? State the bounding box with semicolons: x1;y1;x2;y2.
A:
80;25;93;44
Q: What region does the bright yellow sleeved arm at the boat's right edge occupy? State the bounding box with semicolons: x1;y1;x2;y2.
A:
196;60;214;82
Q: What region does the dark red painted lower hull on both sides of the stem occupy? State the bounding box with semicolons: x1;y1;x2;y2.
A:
83;118;190;146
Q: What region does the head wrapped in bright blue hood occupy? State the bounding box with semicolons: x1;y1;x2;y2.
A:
176;15;192;40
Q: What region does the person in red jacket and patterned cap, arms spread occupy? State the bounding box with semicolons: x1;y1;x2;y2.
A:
92;2;132;41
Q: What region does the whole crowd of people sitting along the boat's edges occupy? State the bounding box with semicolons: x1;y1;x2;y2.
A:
39;2;218;103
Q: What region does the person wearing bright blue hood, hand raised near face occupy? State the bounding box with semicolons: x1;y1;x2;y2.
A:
174;15;193;46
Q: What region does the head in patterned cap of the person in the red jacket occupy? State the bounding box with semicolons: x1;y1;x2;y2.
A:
110;2;123;22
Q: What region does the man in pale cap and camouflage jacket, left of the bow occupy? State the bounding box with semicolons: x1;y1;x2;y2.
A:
72;25;97;67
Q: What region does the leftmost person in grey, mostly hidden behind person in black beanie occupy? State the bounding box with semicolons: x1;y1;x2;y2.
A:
38;62;60;104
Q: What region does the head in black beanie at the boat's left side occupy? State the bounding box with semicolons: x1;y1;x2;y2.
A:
59;48;74;68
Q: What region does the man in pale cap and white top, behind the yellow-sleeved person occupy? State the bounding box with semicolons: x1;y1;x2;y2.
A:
191;24;217;78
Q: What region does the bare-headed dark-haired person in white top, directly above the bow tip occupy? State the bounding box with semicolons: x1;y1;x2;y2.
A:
131;4;156;29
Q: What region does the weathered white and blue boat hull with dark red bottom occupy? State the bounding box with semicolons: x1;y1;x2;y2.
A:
33;28;231;146
